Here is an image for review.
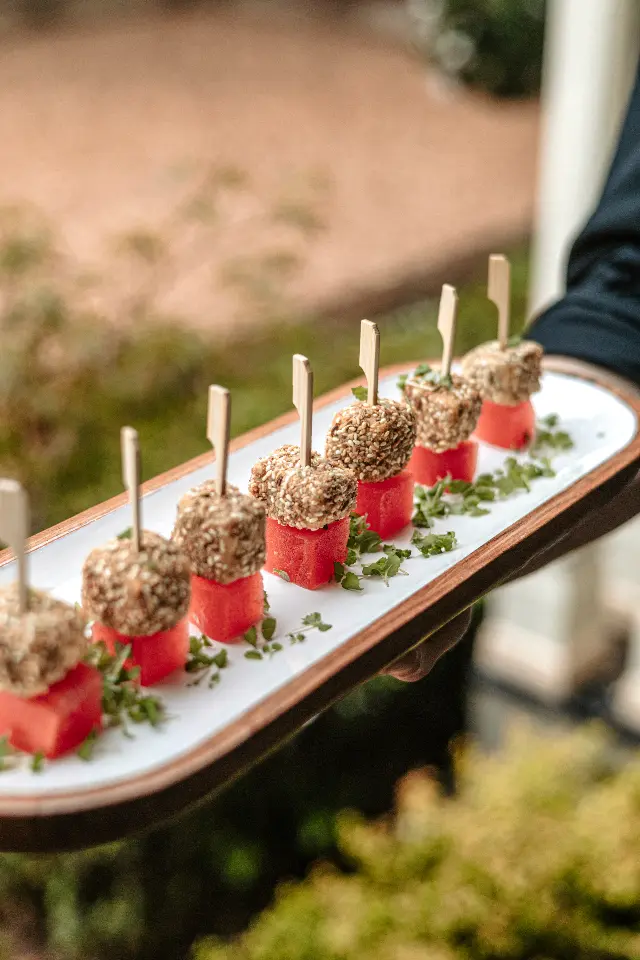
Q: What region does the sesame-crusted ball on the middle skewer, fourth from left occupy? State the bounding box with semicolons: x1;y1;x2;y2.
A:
249;443;358;530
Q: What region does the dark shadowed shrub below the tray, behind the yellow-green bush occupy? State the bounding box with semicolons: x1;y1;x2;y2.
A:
0;624;480;960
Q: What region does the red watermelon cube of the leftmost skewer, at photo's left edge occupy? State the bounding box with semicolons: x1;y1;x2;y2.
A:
0;663;102;760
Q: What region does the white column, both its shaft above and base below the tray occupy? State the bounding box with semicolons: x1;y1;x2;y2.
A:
477;0;640;701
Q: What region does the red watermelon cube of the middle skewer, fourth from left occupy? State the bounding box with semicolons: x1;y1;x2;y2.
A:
265;517;349;590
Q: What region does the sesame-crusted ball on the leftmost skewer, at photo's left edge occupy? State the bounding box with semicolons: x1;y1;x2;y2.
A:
0;583;88;697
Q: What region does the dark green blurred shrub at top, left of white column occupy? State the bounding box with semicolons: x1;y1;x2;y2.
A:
407;0;545;97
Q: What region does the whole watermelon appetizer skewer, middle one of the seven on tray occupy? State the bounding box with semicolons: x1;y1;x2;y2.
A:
249;354;357;590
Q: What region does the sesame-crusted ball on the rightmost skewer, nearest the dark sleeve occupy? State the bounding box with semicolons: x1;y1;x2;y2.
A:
462;340;544;407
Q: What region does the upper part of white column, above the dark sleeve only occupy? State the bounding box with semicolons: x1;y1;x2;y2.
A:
530;0;640;314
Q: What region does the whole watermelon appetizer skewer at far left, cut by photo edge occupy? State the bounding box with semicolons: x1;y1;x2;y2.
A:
0;480;102;759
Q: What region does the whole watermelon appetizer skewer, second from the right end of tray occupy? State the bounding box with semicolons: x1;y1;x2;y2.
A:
403;284;482;487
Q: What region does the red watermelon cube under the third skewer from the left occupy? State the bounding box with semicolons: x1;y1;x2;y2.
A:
189;573;264;643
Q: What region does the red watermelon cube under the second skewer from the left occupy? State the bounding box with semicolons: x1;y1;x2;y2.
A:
92;617;189;687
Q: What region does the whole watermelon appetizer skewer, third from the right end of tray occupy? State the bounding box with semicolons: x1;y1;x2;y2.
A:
325;320;416;539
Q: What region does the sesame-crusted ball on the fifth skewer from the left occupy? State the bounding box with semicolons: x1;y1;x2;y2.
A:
325;400;416;483
